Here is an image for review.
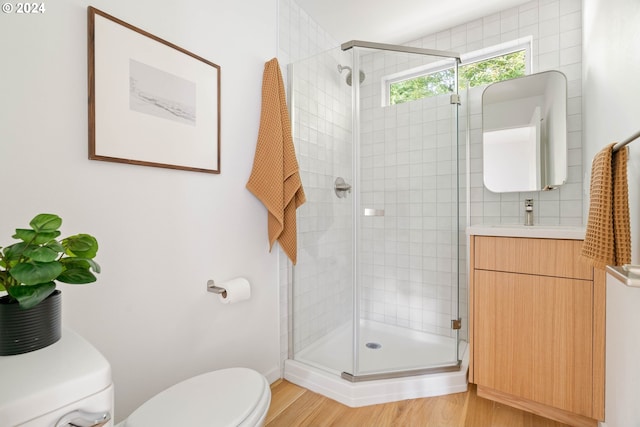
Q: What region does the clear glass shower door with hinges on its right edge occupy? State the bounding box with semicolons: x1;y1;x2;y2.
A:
343;43;459;381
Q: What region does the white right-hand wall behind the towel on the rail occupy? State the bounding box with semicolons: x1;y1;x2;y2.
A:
583;0;640;264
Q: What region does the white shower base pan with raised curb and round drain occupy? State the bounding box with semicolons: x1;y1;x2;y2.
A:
284;321;469;407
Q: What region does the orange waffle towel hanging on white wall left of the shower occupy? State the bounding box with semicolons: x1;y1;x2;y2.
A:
247;58;306;264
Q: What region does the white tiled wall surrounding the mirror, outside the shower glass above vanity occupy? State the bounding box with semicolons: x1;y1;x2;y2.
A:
420;0;583;226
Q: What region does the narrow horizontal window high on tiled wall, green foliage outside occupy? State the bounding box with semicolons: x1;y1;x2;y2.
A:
383;39;531;105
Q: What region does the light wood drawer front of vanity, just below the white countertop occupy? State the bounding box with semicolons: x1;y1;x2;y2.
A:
474;236;593;280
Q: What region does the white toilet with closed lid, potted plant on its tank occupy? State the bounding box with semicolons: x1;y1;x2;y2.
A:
0;328;271;427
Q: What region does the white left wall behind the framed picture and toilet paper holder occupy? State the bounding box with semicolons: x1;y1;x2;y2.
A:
0;0;279;420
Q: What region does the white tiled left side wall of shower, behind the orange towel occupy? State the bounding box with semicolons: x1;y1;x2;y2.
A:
278;0;342;368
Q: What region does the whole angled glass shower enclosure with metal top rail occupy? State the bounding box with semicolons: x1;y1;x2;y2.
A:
287;41;464;382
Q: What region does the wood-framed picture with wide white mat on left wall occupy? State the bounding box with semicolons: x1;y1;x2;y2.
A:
88;7;220;174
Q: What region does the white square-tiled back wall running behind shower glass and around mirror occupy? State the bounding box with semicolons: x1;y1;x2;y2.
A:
361;0;583;344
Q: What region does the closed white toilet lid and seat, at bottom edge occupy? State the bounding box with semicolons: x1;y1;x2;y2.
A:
124;368;271;427
